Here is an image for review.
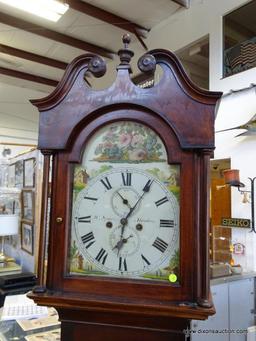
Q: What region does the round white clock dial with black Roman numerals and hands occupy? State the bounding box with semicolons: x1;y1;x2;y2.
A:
73;167;179;277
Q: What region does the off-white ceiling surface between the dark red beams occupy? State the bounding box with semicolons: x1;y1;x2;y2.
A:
0;0;183;144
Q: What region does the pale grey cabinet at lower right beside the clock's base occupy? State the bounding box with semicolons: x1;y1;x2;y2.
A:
191;277;255;341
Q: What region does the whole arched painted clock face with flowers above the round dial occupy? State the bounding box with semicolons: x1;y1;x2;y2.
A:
69;121;180;280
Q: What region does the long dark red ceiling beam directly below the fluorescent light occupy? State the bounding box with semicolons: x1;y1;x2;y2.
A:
0;12;114;59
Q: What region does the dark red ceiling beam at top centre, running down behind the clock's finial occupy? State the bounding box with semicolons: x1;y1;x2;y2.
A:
65;0;150;50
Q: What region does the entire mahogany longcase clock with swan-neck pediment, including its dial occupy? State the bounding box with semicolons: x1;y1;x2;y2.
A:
29;35;221;341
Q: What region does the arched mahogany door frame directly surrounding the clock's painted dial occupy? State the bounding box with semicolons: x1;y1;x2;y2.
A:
52;109;195;301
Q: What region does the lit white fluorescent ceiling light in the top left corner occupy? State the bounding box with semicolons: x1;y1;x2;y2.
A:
0;0;69;21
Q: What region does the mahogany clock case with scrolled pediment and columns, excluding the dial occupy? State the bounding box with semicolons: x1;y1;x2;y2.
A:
30;35;221;341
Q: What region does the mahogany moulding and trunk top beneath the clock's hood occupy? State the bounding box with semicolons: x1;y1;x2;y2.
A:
30;293;215;341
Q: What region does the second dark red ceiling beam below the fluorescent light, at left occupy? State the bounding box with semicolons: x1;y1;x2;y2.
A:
0;44;68;70
